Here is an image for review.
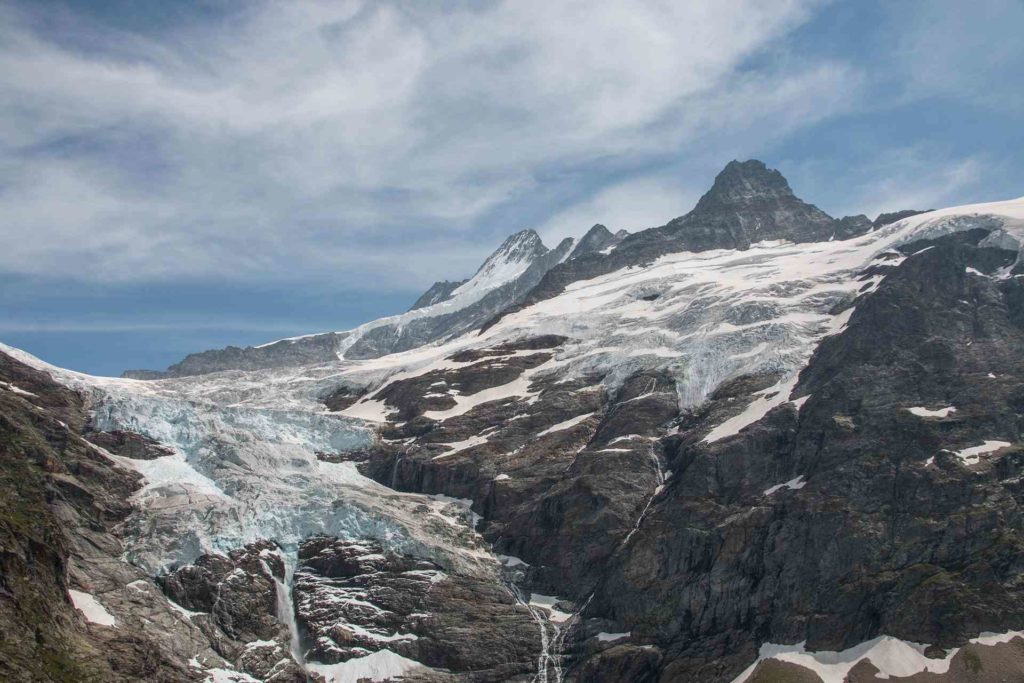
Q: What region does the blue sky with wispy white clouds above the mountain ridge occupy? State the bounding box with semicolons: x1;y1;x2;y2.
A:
0;0;1024;375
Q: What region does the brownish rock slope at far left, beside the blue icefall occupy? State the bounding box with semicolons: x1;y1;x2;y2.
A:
0;353;247;683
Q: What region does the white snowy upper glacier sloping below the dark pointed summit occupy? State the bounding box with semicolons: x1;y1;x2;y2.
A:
340;198;1024;421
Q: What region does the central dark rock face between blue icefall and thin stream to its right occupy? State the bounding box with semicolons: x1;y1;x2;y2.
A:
365;356;678;599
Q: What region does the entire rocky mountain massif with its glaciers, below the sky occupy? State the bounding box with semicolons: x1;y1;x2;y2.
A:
0;161;1024;683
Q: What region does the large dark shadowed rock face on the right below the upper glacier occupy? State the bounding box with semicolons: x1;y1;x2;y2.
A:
580;234;1024;681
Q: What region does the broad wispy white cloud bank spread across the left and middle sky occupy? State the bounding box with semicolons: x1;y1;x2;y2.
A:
0;0;839;287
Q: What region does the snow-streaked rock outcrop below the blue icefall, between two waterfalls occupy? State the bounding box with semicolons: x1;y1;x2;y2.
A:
295;537;541;682
